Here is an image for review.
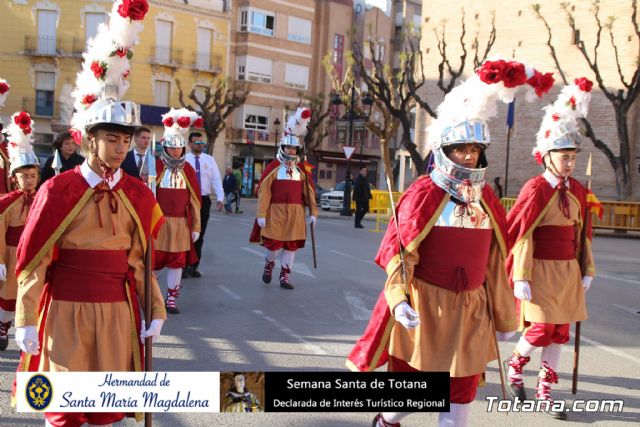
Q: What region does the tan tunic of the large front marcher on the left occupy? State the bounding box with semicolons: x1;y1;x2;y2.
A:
16;193;166;371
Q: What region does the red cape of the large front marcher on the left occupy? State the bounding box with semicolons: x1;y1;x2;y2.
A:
14;166;164;391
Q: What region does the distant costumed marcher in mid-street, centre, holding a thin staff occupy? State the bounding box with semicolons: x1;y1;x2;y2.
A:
250;108;318;289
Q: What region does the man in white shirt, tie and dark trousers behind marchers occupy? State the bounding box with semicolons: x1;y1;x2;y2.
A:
182;132;224;279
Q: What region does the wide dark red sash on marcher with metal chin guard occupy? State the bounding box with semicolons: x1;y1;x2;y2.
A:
414;227;491;292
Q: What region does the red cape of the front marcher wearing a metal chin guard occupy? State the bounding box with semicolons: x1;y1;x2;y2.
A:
346;176;507;372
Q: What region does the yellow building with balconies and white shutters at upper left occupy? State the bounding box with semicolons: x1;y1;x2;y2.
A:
0;0;231;166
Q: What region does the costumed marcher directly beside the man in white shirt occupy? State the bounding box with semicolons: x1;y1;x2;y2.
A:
154;108;202;314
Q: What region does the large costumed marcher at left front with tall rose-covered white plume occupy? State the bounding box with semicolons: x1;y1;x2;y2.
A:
15;1;166;426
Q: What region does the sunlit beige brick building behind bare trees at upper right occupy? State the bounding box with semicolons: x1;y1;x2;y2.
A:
416;0;640;200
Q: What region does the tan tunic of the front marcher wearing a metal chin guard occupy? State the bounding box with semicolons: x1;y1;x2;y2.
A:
385;201;517;377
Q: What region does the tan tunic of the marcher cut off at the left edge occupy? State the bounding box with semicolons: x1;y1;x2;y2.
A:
0;196;29;300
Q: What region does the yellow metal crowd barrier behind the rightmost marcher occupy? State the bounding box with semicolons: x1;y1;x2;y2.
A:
500;197;640;231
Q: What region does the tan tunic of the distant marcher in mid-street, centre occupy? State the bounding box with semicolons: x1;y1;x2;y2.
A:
256;167;318;242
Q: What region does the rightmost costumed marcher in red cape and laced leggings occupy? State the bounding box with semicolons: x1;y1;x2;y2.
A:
505;78;595;419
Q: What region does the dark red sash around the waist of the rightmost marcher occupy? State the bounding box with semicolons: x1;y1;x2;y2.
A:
533;225;577;260
